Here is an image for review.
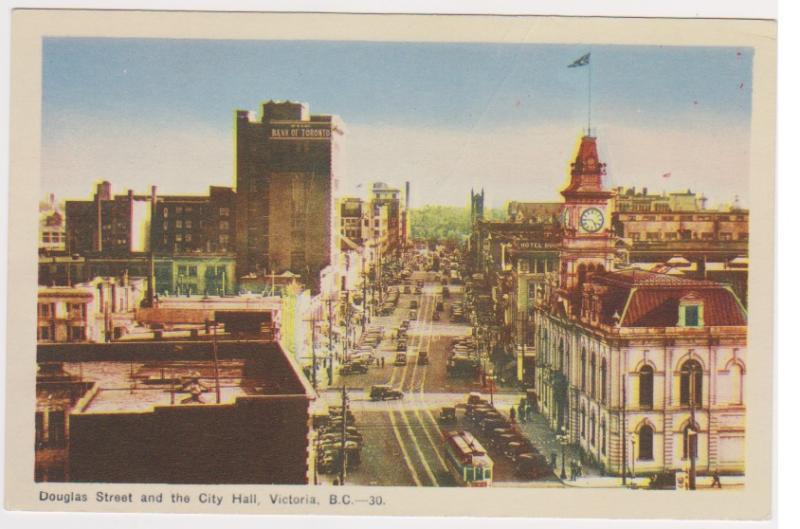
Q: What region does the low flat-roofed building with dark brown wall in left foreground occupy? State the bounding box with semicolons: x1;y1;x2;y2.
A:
59;342;314;485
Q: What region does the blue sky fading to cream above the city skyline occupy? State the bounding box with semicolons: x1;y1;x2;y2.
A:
41;38;753;207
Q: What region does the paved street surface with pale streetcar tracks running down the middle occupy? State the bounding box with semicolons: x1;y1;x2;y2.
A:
317;272;560;486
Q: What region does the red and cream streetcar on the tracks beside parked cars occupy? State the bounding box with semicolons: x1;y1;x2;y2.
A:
444;431;494;487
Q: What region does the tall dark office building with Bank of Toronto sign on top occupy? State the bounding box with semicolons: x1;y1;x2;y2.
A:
236;101;344;292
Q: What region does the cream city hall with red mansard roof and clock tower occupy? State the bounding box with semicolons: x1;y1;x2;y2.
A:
528;136;747;475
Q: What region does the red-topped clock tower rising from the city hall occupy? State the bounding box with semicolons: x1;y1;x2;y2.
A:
560;135;615;291
